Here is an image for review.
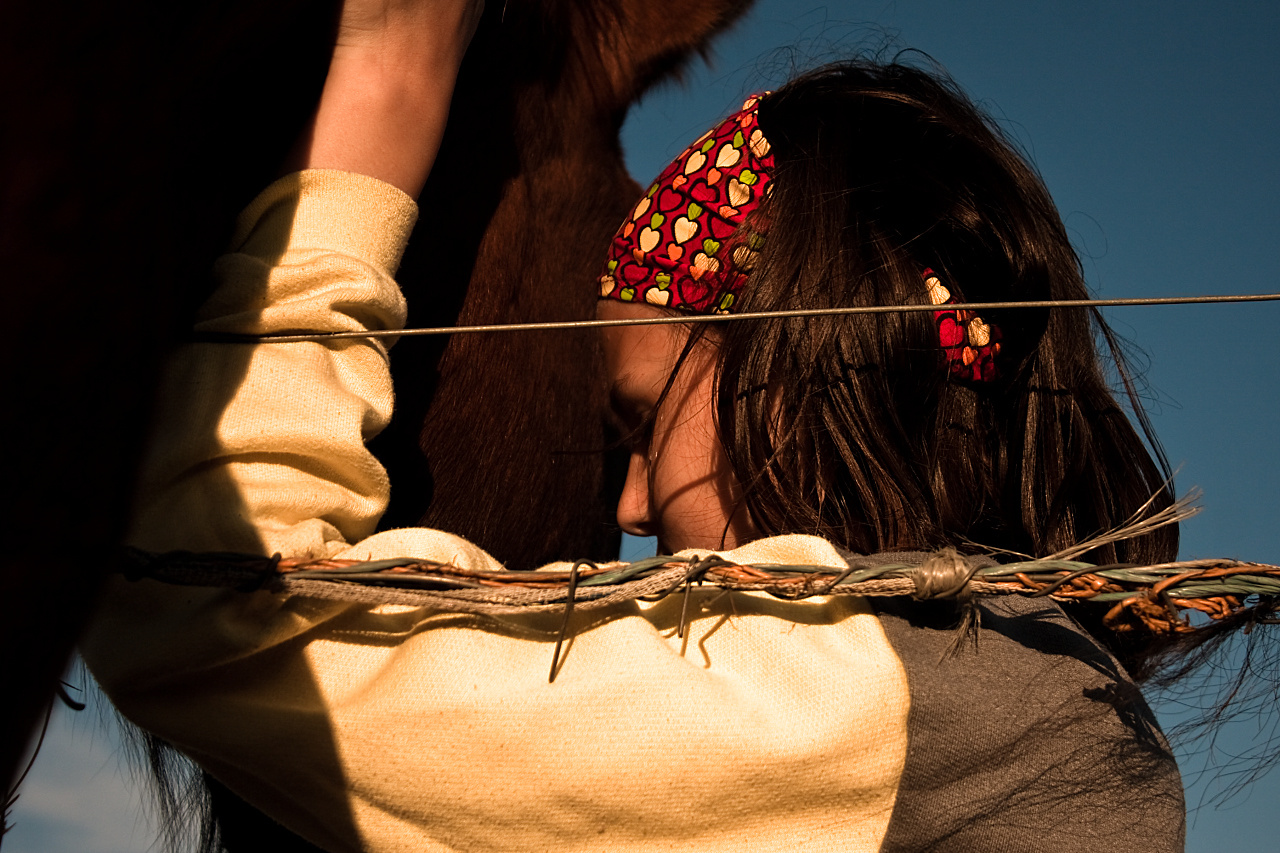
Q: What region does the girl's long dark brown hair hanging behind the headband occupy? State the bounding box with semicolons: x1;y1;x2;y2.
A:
717;61;1178;645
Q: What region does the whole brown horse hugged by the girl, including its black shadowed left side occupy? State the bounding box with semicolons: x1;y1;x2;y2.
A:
0;0;749;849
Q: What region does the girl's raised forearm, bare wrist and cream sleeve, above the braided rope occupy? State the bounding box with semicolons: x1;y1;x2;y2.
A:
117;0;480;556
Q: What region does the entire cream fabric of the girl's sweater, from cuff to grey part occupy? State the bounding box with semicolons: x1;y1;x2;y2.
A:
83;172;909;853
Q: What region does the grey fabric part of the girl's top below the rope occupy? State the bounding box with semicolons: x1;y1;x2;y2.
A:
876;596;1185;853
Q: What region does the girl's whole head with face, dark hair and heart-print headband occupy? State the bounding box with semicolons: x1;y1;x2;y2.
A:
600;61;1176;562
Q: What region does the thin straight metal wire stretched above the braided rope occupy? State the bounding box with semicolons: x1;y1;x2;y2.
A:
193;293;1280;343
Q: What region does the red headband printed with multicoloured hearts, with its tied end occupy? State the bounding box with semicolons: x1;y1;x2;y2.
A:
600;92;1001;382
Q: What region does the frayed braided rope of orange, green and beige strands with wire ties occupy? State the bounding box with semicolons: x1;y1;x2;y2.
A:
122;548;1280;634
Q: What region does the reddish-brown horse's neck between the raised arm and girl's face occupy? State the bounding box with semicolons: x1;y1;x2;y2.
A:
375;0;745;567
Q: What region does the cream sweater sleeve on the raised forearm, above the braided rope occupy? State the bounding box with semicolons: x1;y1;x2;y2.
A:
129;172;417;556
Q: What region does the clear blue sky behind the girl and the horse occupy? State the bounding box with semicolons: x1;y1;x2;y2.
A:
5;0;1280;853
